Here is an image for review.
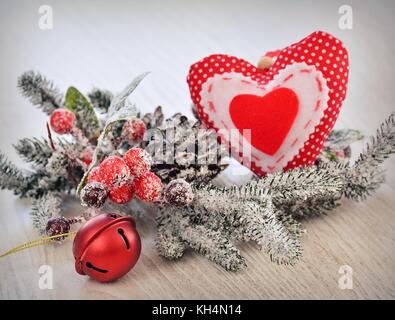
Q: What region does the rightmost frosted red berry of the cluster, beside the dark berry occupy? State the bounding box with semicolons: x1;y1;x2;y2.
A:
132;172;162;202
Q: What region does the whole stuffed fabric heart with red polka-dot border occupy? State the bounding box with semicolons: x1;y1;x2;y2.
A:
187;31;349;175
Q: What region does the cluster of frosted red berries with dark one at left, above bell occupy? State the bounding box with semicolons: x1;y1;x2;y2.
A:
81;148;162;207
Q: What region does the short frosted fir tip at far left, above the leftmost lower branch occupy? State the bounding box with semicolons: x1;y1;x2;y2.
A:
14;138;53;166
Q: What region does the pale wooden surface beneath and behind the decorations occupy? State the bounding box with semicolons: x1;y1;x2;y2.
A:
0;0;395;299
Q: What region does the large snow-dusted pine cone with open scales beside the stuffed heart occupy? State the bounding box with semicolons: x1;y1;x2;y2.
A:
141;113;227;183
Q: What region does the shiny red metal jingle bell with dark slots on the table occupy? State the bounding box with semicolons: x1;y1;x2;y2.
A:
73;213;141;282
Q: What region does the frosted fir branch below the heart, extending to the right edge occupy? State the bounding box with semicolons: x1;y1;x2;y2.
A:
270;113;395;206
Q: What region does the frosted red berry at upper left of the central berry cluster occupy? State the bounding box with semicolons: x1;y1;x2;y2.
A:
98;156;130;187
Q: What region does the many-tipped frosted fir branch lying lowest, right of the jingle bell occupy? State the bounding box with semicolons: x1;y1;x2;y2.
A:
157;185;302;271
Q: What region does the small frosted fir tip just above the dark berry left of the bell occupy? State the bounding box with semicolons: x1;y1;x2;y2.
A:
30;193;62;235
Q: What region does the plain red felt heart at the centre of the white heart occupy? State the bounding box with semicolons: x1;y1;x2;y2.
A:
229;88;299;156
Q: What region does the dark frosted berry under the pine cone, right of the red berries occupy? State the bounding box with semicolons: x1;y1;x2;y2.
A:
163;179;193;206
